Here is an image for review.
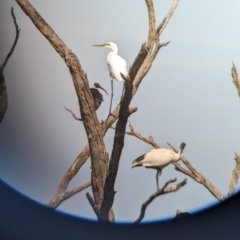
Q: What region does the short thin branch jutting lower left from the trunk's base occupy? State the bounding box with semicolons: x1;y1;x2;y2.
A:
47;181;91;209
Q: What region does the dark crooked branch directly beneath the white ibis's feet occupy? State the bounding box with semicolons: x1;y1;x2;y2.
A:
134;178;187;224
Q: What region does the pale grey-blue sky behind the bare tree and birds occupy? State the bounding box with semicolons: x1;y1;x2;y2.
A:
0;0;240;222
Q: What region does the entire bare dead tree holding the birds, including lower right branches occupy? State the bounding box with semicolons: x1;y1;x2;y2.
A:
13;0;240;223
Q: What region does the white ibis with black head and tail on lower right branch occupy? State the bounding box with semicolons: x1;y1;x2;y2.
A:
132;142;186;190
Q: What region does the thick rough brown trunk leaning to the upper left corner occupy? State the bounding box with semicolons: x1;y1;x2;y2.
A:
16;0;108;221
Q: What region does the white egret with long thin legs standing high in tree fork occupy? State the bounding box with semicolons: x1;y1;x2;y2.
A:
93;42;128;114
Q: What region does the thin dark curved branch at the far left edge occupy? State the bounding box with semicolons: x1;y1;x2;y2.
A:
0;7;20;122
